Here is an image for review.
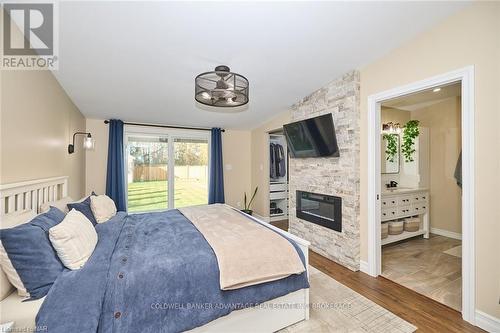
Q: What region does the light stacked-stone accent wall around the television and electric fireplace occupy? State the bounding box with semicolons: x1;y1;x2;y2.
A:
289;71;360;270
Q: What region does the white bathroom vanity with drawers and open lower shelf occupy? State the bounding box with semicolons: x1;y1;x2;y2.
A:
381;188;430;245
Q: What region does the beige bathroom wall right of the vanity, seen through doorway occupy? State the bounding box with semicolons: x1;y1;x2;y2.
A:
411;97;462;233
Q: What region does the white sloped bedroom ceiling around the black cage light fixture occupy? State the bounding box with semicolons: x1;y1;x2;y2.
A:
55;1;466;129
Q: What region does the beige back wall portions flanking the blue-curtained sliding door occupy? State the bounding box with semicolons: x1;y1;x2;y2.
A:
85;119;251;207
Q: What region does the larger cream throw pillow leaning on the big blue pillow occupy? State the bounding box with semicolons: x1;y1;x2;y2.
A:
49;209;97;270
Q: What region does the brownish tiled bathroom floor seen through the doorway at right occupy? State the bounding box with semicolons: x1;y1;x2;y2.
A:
382;235;462;311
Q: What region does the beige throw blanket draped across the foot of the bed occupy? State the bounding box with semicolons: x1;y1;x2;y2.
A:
179;204;305;290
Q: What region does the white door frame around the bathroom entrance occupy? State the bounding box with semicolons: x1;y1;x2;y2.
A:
367;66;476;324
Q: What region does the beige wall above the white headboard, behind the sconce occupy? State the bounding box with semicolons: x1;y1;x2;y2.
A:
0;71;85;199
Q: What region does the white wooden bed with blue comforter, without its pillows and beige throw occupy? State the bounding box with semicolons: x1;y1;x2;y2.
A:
0;177;309;332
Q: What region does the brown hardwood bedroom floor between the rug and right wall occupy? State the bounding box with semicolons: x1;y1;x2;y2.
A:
273;221;484;333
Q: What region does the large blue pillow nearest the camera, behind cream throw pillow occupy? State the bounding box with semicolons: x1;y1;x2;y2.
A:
0;207;65;299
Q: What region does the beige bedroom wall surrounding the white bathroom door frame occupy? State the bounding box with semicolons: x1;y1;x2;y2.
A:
360;2;500;318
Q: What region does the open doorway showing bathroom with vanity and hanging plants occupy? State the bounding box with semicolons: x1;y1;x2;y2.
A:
380;82;462;311
